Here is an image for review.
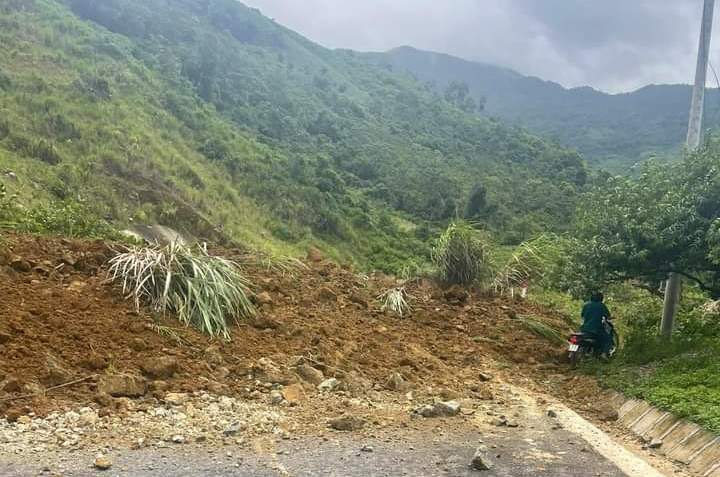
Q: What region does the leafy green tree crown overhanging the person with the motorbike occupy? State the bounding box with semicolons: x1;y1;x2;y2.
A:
570;139;720;297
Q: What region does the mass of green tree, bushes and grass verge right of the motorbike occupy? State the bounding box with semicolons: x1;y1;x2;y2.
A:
553;138;720;431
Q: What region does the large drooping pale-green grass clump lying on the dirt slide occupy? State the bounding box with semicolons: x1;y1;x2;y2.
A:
110;242;255;339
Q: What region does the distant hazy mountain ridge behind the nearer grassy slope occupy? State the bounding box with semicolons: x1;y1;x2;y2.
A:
368;47;720;172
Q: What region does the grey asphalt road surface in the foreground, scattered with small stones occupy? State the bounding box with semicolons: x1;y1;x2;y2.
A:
0;426;625;477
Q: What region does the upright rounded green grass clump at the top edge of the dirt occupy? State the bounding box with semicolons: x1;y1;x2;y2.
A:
432;222;490;286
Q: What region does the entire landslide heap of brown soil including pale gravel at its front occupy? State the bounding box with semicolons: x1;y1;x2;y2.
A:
0;234;684;476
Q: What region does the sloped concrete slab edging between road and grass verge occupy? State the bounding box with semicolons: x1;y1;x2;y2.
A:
606;391;720;477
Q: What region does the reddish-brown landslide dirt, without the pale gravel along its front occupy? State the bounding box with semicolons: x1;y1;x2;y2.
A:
0;235;582;422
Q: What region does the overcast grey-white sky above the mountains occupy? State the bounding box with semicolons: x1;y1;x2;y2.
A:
243;0;720;92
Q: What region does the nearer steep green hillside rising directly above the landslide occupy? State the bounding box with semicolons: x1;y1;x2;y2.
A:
0;0;587;270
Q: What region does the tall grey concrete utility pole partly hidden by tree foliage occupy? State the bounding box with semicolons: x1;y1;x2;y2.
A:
660;0;715;338
